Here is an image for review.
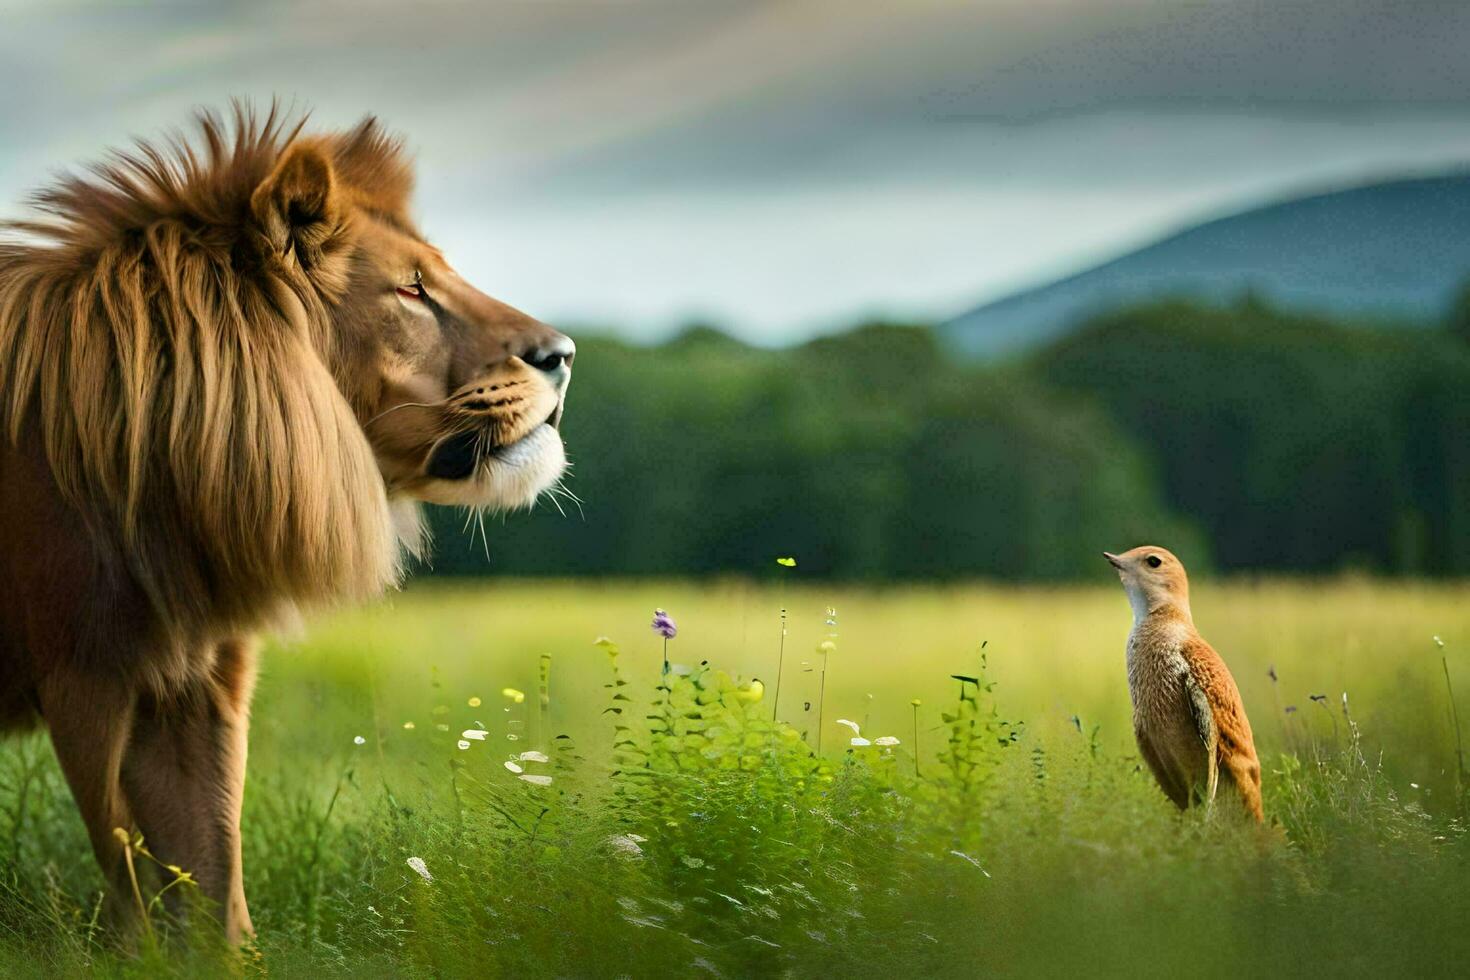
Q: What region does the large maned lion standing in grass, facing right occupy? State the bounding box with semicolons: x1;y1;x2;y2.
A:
0;103;575;942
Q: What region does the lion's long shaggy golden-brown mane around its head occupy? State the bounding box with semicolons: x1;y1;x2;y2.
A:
0;104;410;630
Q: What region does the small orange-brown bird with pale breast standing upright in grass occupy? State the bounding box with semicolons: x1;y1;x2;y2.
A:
1103;545;1263;823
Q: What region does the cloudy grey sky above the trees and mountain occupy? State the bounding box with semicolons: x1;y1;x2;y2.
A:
0;0;1470;344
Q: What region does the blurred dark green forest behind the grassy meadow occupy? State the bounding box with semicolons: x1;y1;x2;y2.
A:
417;298;1470;580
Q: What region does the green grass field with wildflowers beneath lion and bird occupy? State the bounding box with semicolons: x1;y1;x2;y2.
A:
0;578;1470;977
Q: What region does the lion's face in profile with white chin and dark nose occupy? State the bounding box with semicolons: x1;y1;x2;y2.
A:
334;204;576;508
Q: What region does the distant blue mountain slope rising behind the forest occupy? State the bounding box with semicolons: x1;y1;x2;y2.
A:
941;173;1470;357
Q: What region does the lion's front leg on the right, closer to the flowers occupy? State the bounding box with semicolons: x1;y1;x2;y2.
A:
122;641;254;943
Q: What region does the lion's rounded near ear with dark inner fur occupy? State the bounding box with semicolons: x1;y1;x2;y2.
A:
250;143;343;269
